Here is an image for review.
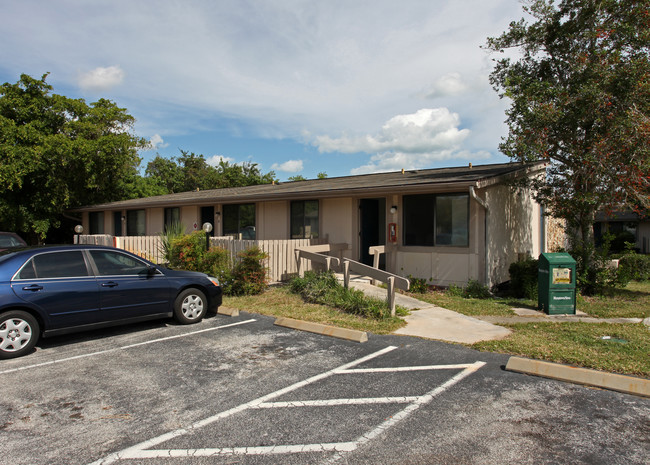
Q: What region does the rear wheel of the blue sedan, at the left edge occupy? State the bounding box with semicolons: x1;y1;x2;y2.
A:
0;310;39;359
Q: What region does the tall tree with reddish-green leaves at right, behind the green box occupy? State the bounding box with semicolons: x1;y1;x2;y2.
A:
487;0;650;290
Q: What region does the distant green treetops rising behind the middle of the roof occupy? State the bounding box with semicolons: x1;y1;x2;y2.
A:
145;150;275;193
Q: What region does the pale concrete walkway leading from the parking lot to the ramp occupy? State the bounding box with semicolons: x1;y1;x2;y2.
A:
350;281;510;344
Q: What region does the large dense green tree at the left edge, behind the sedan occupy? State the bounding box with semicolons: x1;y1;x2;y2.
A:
0;74;146;239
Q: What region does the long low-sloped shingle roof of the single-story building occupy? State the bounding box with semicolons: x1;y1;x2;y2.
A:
73;163;544;212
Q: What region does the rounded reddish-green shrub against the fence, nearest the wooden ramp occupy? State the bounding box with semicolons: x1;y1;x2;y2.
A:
224;247;269;295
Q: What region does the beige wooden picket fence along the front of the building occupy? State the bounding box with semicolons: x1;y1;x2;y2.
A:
74;234;327;282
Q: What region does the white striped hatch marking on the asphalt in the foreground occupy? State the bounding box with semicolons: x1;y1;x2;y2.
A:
85;346;485;465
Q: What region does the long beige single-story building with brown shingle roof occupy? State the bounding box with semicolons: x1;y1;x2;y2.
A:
75;163;547;286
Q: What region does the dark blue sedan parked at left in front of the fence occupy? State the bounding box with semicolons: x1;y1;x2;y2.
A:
0;245;221;359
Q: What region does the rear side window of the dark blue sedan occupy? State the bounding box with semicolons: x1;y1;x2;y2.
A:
17;251;88;279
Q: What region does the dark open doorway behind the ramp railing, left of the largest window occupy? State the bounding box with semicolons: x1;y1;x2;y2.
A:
359;198;386;269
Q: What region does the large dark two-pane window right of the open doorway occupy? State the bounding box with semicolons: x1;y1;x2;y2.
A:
403;194;469;247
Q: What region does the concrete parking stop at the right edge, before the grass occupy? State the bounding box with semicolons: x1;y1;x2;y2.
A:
506;357;650;397
